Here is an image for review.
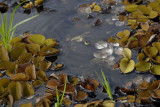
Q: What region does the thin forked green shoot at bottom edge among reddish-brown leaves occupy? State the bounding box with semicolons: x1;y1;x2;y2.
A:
55;80;67;107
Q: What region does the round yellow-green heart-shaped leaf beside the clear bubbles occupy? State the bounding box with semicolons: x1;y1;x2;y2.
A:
120;58;135;73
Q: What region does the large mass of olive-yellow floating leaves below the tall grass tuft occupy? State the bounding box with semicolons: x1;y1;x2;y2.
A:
0;34;59;105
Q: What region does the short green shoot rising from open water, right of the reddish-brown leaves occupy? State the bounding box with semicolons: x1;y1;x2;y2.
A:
95;70;113;100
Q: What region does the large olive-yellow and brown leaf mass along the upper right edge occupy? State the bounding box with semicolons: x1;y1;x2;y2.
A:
108;0;160;75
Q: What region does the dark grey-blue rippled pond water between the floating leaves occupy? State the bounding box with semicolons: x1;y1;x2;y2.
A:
0;0;156;107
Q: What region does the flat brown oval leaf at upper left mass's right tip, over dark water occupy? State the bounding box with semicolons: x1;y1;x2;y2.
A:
39;46;59;56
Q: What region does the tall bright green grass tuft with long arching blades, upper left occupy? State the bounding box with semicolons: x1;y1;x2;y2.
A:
0;2;39;50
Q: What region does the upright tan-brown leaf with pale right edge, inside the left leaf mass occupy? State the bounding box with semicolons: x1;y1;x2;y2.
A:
25;64;36;80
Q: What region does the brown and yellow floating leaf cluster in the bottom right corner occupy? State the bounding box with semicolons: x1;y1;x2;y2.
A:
117;80;160;104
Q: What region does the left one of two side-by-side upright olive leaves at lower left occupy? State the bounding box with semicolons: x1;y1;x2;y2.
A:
8;81;21;101
